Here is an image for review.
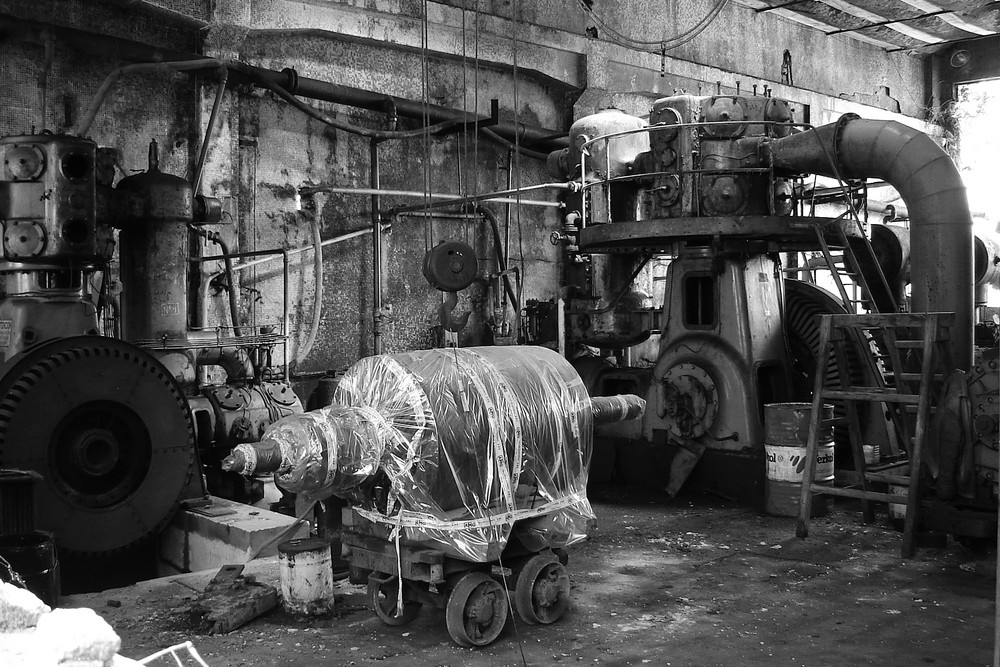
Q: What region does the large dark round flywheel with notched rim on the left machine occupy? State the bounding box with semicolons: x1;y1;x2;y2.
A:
0;336;195;556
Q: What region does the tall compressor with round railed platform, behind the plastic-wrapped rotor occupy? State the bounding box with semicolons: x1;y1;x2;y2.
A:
544;94;998;528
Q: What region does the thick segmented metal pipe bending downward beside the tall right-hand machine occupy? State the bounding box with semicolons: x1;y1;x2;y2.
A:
770;117;973;370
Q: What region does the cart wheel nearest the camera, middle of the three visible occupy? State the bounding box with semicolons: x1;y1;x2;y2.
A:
445;572;509;646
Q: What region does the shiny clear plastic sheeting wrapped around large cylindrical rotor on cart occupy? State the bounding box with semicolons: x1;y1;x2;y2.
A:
247;347;595;562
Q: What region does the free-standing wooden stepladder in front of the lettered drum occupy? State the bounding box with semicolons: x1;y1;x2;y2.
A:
795;313;955;558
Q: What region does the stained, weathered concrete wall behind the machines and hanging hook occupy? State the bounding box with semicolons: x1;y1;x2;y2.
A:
0;0;925;394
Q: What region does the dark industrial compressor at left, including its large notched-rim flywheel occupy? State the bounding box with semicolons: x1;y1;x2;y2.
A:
0;133;301;557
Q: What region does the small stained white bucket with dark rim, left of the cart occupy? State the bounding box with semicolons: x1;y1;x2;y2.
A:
278;537;334;614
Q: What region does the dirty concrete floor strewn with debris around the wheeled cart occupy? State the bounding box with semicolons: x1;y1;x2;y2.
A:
65;486;995;667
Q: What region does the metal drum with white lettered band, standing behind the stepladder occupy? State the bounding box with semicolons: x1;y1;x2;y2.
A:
764;403;834;517
